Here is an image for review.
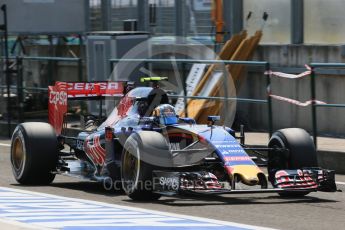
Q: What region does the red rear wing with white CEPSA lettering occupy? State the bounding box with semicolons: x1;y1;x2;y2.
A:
48;82;126;135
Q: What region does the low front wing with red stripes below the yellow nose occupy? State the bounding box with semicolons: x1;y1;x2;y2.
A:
152;168;337;195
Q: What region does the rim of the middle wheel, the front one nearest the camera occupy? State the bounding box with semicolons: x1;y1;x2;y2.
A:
122;148;140;193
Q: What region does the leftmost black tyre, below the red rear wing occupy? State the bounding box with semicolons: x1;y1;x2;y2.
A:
11;122;58;185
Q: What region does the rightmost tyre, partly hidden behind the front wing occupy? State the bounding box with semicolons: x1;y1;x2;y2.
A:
267;128;318;197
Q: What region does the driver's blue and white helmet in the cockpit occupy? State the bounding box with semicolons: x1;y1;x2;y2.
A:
153;104;178;125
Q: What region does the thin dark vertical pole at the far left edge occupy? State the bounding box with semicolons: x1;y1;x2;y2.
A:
1;4;11;137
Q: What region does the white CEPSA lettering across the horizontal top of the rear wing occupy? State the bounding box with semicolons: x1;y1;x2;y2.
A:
67;82;120;91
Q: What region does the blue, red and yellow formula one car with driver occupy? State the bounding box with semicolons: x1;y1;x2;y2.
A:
11;77;336;200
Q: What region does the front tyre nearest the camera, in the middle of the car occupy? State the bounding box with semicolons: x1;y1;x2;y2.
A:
121;131;169;201
